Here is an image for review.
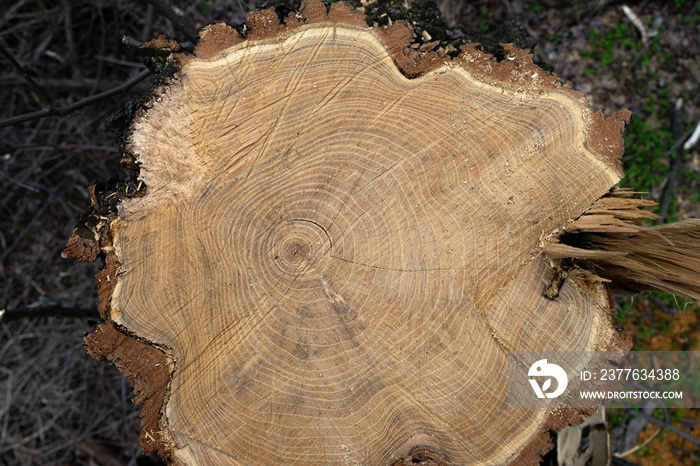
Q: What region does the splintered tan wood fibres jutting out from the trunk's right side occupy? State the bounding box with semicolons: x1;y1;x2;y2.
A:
544;189;700;302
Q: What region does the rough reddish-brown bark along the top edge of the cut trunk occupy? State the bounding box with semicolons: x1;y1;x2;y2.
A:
187;0;632;173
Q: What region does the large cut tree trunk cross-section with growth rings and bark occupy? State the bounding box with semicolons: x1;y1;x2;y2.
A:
66;1;698;465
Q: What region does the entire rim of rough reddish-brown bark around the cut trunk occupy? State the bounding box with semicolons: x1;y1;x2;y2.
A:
64;0;631;460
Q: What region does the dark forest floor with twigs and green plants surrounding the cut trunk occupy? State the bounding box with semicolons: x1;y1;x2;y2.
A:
0;0;700;465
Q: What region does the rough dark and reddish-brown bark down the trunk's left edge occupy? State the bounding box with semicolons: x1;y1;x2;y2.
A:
61;16;196;459
